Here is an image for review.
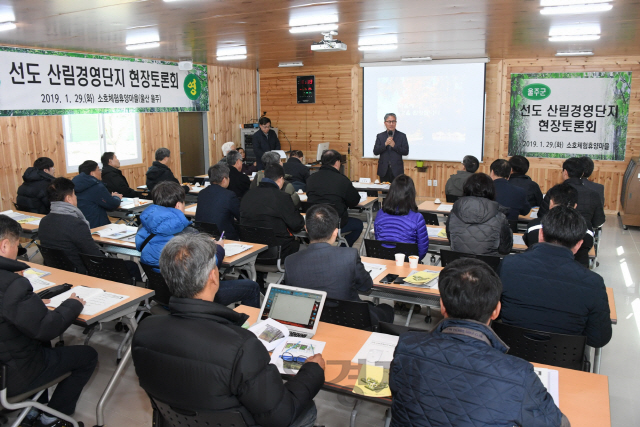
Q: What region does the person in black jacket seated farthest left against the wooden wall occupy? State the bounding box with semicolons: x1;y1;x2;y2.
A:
16;157;56;214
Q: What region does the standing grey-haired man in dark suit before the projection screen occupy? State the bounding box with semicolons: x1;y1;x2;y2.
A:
373;113;409;182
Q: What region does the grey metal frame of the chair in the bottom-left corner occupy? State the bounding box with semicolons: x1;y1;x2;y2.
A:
0;364;78;427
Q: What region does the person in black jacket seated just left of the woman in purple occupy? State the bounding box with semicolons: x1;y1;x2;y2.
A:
307;150;364;246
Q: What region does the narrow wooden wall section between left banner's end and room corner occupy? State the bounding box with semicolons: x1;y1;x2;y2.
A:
207;65;259;164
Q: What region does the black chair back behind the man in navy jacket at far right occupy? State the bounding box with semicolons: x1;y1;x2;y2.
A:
491;322;591;372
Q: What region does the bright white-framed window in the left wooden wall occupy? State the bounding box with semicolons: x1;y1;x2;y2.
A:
63;113;142;173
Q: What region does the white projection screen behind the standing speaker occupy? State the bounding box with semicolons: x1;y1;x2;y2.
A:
363;63;485;161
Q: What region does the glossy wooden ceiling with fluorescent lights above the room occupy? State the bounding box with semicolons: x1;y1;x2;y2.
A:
0;0;640;68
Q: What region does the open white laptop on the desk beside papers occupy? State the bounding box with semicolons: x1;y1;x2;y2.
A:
258;283;327;338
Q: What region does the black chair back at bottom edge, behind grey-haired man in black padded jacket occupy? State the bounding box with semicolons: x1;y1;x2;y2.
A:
149;396;247;427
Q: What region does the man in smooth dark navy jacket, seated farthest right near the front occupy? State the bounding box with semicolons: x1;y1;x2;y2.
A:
499;206;611;347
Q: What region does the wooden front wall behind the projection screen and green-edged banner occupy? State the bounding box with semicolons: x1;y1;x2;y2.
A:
260;57;640;212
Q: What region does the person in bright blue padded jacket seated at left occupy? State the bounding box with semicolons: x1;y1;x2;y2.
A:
136;181;260;307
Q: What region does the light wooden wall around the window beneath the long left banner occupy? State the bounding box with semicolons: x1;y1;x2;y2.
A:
0;113;180;210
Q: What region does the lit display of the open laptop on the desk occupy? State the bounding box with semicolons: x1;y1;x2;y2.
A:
260;286;322;329
